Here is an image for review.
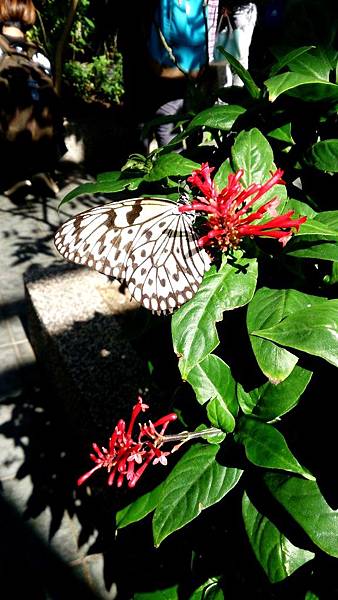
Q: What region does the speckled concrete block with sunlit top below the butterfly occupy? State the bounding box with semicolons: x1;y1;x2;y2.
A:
24;262;148;443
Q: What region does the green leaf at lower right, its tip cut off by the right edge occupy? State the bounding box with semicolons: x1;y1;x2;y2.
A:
264;473;338;558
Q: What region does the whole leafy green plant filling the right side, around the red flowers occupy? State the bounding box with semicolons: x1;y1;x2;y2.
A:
64;14;338;599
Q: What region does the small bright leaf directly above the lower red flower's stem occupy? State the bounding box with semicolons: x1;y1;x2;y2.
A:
187;354;238;431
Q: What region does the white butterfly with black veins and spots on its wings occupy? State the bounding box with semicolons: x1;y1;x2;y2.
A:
54;198;210;314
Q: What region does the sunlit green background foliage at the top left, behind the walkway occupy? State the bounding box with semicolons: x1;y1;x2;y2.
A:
33;0;123;104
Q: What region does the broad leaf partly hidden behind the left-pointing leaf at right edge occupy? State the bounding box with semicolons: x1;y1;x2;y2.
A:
247;288;322;383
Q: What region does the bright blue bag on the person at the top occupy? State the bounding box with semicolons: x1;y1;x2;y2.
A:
149;0;208;77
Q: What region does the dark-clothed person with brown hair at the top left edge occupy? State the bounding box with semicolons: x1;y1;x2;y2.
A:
0;0;66;199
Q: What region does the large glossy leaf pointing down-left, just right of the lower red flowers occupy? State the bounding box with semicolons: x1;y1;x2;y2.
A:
153;444;242;546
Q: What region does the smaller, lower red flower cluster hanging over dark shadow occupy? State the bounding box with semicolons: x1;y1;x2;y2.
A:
77;397;177;488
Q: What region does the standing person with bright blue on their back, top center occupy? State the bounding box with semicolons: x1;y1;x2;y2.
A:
118;0;219;153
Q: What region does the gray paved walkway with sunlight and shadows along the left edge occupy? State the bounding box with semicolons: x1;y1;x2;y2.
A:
0;161;116;600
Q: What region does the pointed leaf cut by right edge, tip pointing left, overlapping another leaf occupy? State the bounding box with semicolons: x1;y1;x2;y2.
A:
251;299;338;367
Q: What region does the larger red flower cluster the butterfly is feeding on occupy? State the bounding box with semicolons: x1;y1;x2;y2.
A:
179;163;306;251
